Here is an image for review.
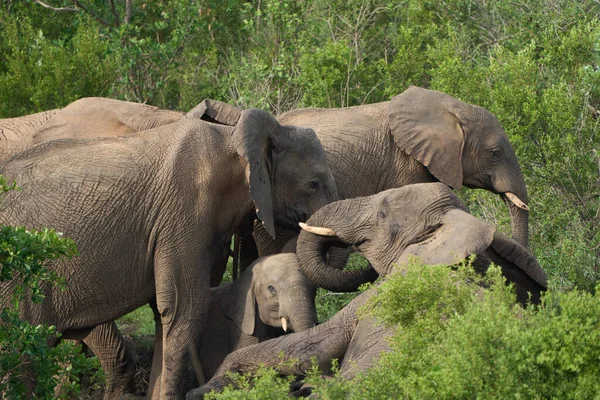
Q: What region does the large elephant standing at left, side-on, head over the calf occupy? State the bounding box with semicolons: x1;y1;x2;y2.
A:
0;106;336;398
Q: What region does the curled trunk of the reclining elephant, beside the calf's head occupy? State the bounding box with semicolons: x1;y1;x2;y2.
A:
296;197;378;292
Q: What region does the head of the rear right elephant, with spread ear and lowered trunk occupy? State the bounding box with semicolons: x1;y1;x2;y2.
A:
389;86;529;247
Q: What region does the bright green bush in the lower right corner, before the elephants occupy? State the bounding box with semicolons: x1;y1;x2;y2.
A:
332;267;600;398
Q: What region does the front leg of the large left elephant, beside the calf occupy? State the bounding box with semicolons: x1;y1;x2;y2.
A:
154;252;211;399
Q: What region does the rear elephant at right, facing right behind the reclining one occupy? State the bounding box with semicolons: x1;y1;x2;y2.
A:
251;86;529;272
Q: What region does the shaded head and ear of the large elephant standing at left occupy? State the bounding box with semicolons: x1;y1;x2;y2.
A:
232;109;337;239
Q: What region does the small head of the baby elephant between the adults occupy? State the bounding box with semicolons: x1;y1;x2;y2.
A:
221;253;317;335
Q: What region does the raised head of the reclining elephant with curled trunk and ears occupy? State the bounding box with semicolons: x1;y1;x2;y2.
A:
297;183;547;301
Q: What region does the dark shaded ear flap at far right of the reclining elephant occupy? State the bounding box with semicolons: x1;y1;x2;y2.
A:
485;232;548;304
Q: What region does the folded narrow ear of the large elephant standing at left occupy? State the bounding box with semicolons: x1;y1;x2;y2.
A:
232;109;285;239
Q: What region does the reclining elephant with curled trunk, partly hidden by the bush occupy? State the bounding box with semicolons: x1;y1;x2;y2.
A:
187;183;547;399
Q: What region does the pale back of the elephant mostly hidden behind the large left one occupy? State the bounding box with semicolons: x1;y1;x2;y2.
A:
0;97;184;160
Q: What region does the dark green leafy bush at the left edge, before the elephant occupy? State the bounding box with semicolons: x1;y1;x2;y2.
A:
0;176;98;399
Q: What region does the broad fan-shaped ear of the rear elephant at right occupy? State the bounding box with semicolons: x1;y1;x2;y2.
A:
388;86;473;189
